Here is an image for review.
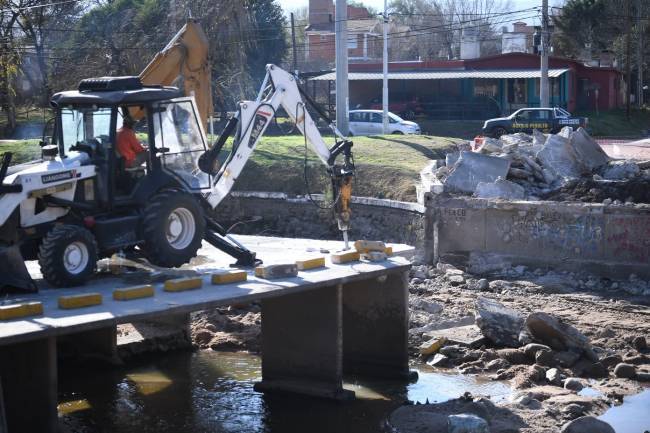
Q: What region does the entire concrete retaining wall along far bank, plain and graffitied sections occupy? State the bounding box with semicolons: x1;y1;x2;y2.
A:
218;192;650;278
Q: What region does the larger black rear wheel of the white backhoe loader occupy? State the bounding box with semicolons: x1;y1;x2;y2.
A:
142;190;205;268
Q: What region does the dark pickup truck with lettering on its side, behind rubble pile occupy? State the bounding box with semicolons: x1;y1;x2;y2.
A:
483;107;588;138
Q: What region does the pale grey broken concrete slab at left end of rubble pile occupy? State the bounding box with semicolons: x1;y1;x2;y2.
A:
445;152;510;194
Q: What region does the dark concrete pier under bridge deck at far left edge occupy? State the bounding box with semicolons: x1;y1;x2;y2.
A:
0;337;58;433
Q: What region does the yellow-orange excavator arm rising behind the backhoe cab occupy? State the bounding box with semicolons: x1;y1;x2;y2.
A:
136;19;213;131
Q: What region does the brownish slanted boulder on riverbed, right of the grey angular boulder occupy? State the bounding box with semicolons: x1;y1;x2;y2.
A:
526;312;598;361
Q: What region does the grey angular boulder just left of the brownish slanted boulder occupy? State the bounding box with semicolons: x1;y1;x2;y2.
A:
476;296;524;347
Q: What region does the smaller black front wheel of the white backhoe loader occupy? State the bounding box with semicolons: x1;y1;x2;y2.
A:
38;224;97;287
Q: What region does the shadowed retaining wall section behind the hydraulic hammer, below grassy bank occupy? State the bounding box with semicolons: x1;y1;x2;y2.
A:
217;192;425;248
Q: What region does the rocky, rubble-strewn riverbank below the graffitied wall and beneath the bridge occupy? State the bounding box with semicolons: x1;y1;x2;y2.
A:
187;264;650;433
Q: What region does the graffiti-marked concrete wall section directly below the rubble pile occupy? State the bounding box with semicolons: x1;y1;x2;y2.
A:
427;196;650;277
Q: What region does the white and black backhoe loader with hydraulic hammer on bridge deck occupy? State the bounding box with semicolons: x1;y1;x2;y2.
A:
0;21;355;292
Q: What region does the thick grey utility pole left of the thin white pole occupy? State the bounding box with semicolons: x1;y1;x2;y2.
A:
334;0;350;135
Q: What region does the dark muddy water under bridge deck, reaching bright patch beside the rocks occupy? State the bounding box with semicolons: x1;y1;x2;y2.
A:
59;351;510;433
